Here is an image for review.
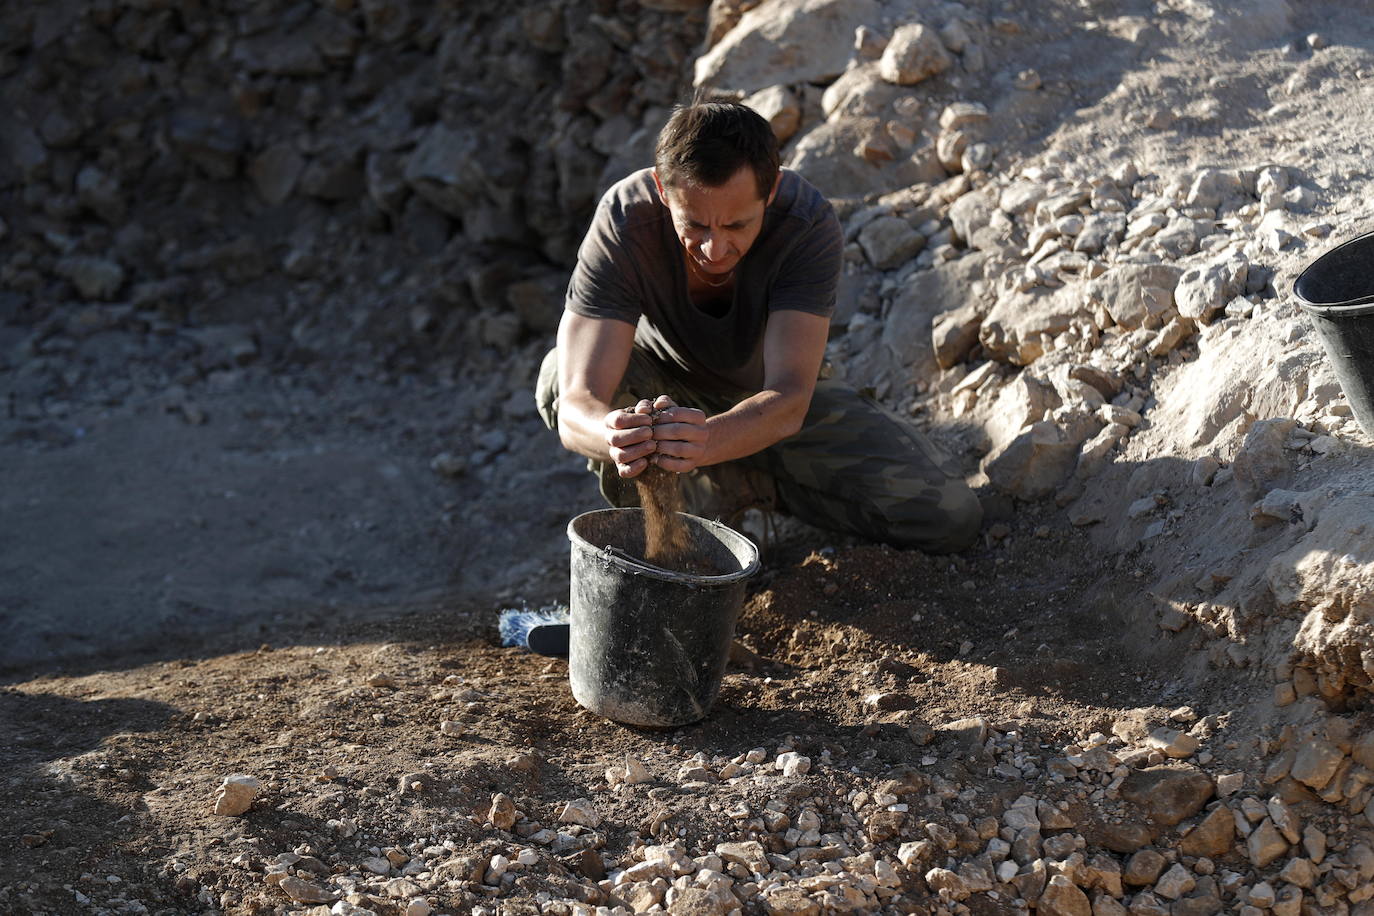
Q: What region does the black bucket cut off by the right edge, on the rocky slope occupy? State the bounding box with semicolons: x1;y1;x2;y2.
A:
1293;232;1374;437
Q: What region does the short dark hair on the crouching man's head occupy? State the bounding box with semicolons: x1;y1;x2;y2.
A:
654;102;779;201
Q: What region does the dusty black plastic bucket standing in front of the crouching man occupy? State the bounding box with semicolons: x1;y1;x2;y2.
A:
567;508;758;728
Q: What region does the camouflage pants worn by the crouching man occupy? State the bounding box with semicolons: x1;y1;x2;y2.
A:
534;347;982;553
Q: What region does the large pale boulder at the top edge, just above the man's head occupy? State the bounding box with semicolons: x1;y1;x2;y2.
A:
694;0;881;92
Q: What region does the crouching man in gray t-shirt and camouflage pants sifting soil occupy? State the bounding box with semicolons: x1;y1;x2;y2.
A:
536;102;982;552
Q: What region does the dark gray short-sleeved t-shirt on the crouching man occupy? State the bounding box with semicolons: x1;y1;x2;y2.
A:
566;169;844;391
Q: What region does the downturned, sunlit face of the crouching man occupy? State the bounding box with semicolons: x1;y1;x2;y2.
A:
654;166;778;276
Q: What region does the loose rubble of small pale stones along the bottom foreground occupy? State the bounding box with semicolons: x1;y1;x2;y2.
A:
200;707;1374;916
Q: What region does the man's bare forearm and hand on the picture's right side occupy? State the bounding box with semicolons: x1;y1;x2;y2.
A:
653;309;830;471
